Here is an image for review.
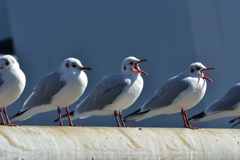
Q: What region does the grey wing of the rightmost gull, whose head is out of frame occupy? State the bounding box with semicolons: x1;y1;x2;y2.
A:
204;83;240;115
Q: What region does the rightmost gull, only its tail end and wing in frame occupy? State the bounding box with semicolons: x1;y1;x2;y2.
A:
189;83;240;127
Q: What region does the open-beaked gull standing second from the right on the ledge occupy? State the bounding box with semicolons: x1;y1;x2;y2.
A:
124;62;213;129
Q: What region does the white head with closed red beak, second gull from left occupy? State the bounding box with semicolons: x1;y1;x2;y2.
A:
59;58;92;72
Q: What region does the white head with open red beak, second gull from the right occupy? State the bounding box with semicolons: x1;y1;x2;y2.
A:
186;62;214;82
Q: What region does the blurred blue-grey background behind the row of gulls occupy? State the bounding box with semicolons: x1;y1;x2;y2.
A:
0;0;240;128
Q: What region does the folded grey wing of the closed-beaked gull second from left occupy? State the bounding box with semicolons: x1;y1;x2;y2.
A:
23;72;66;110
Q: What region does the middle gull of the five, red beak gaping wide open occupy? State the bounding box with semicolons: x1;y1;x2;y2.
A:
55;56;147;127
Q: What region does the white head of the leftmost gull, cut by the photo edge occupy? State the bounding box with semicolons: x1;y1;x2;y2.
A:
0;55;19;72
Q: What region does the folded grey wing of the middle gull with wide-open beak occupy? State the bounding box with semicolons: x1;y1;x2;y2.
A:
74;75;128;114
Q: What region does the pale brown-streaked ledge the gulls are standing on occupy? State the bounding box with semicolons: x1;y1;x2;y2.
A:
0;126;240;160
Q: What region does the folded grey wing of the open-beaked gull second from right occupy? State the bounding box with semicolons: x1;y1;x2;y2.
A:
141;76;189;111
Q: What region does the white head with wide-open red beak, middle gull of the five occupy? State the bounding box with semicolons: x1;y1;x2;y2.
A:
121;56;148;75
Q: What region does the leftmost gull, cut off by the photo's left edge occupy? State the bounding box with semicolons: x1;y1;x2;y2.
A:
0;55;26;126
